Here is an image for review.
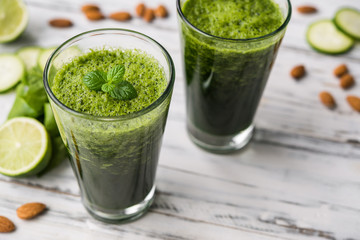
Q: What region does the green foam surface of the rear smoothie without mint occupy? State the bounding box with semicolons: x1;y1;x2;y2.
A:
182;0;283;39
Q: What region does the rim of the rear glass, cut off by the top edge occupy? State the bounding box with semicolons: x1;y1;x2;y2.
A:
176;0;292;42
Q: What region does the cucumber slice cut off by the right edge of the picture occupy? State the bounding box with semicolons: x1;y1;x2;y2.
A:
334;8;360;40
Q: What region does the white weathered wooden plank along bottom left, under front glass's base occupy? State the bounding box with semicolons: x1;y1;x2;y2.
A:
0;181;276;240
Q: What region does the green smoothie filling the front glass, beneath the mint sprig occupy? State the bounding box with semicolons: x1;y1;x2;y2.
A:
50;49;171;217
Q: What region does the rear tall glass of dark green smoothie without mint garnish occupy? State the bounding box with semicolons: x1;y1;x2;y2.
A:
177;0;291;153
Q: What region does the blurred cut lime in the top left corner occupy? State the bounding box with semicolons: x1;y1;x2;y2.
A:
0;0;29;43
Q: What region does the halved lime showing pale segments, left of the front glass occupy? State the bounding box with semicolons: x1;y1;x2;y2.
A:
0;117;51;177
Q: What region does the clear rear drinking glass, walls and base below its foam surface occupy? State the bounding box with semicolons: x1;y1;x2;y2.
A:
177;0;291;153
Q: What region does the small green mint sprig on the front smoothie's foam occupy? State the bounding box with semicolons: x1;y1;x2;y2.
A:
83;65;137;101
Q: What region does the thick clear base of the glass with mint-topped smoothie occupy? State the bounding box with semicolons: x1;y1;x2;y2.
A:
83;186;155;223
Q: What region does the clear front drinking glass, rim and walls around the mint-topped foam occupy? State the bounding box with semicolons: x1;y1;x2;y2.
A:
44;29;175;222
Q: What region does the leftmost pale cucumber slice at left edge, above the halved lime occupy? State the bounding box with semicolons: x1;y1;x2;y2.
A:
0;54;25;92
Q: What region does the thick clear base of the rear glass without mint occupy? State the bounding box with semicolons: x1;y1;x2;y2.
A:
187;121;254;153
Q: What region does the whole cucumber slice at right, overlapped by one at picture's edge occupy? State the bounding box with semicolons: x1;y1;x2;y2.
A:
306;20;354;54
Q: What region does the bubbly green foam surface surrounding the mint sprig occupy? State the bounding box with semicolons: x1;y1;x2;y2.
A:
51;49;167;117
